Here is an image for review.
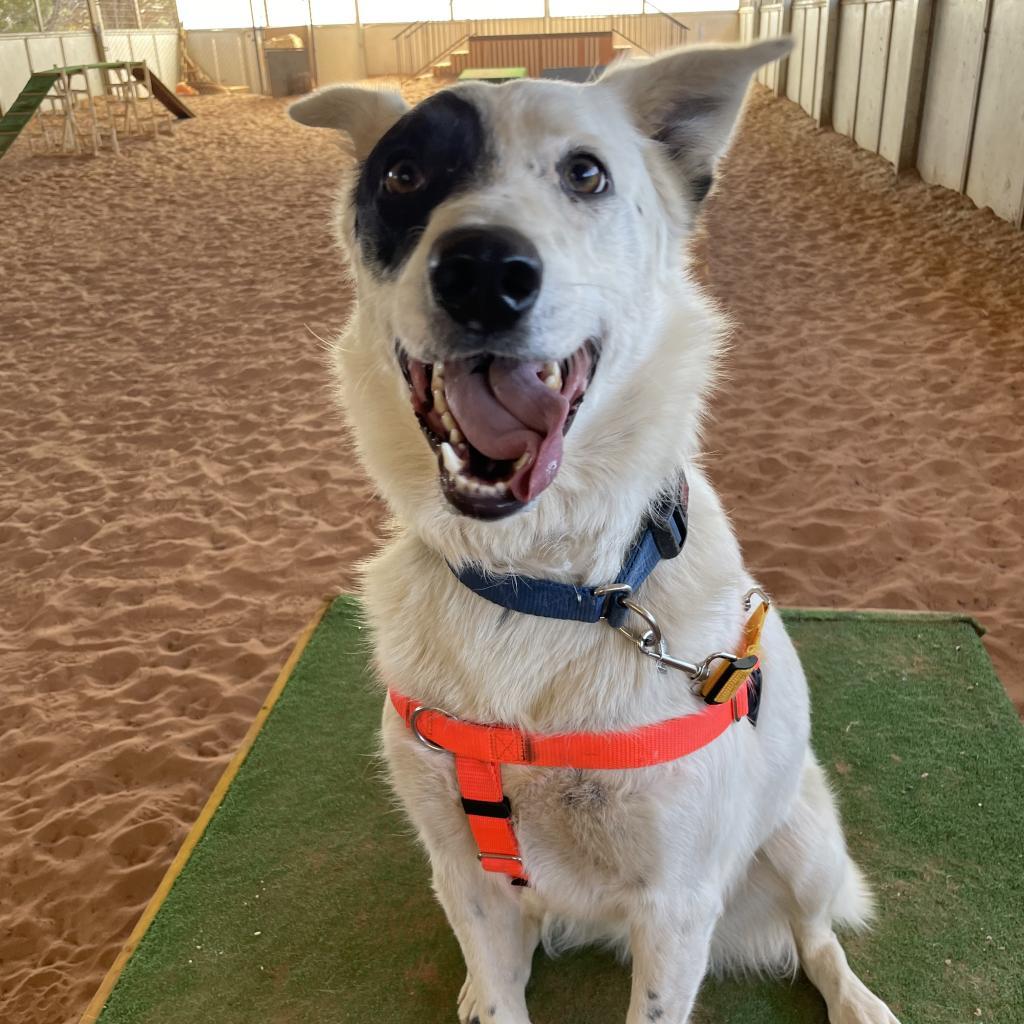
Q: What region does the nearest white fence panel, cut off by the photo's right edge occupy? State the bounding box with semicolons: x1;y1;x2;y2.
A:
967;0;1024;227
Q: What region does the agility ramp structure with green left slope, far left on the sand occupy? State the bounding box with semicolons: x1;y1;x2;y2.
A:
0;60;195;157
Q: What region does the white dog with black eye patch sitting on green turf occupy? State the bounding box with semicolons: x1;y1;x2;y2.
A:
291;39;896;1024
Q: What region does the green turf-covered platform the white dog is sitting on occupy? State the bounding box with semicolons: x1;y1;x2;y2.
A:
88;598;1024;1024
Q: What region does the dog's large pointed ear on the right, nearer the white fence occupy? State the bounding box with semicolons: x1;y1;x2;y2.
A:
596;37;793;202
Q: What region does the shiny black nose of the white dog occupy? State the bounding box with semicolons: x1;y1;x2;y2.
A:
430;227;541;333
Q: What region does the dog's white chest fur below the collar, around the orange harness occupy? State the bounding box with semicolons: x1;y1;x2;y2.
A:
367;475;806;918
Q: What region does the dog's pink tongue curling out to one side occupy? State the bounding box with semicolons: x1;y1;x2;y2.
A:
444;358;569;502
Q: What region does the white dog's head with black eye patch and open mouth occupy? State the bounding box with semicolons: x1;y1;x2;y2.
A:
291;39;790;544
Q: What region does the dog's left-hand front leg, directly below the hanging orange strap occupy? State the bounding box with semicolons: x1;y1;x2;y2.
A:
434;857;540;1024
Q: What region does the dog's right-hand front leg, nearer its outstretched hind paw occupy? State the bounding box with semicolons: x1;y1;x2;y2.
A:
627;895;721;1024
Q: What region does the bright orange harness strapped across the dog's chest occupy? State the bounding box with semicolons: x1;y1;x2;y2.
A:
388;603;768;886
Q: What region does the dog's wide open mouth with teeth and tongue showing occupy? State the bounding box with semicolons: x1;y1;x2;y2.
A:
395;341;598;519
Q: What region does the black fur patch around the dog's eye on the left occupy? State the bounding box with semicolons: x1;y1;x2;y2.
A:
353;91;485;271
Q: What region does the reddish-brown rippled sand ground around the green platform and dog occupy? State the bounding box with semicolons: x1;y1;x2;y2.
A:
0;88;1024;1024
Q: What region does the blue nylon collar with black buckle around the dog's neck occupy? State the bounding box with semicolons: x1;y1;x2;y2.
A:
452;474;689;626
